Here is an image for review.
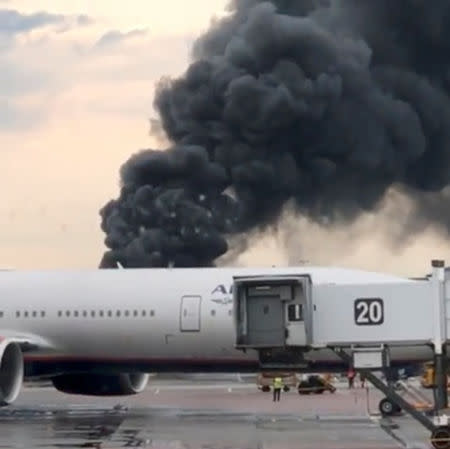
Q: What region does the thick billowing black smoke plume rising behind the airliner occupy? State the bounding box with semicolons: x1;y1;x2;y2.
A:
101;0;450;267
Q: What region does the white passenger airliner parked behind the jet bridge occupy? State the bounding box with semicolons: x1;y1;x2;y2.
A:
0;267;433;405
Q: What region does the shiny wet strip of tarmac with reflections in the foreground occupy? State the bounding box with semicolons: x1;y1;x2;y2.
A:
0;409;396;449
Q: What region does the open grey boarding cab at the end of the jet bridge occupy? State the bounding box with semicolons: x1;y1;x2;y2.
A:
233;275;312;368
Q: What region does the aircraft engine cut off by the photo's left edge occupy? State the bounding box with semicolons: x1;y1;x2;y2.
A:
0;339;24;407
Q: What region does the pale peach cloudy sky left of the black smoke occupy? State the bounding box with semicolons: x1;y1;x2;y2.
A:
0;0;227;269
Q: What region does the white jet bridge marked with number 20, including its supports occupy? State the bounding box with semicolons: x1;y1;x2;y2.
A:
233;261;450;449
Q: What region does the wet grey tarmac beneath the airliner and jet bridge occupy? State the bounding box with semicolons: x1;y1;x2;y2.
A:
0;377;431;449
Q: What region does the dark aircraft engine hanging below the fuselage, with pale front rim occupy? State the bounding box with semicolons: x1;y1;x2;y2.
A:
52;373;149;396
